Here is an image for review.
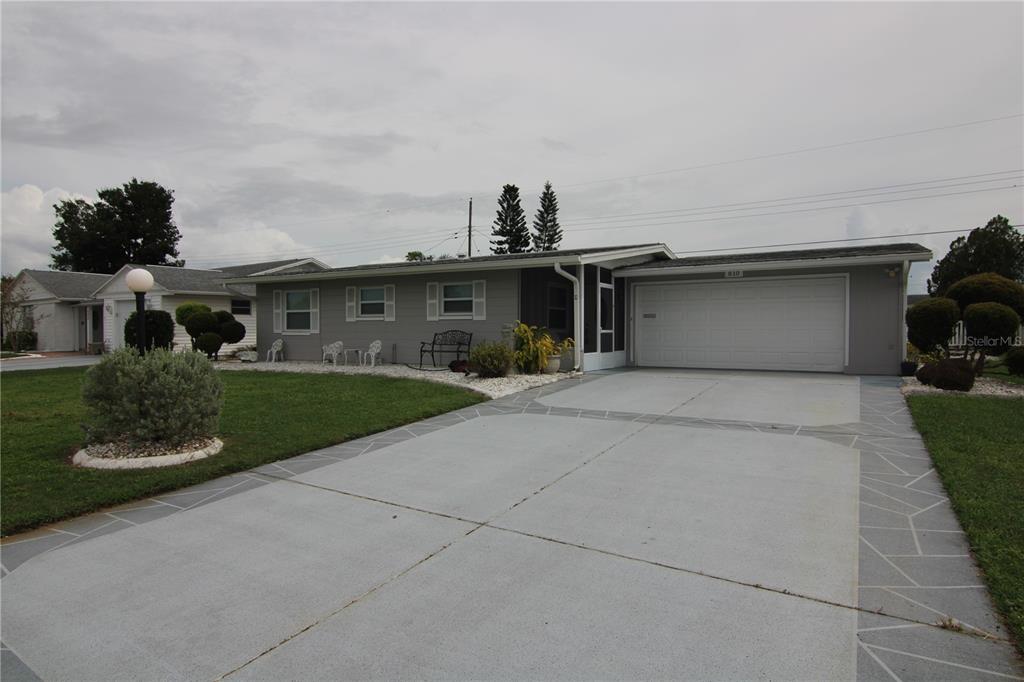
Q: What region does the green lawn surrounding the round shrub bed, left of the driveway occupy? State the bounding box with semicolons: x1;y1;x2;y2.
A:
0;368;485;535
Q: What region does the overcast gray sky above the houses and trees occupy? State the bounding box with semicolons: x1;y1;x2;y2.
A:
0;2;1024;291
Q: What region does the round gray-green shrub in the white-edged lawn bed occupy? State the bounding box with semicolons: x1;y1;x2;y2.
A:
82;348;224;445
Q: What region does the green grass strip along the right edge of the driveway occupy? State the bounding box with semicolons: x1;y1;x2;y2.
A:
907;395;1024;647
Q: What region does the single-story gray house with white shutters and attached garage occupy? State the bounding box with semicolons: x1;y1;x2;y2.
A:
225;244;932;374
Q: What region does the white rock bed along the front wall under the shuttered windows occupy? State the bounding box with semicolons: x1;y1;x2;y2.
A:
216;360;580;398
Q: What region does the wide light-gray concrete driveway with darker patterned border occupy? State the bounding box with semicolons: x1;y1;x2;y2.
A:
0;372;1021;680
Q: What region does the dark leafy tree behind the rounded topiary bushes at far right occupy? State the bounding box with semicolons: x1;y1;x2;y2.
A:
928;215;1024;296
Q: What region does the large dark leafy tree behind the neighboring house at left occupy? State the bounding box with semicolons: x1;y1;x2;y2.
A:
52;178;184;272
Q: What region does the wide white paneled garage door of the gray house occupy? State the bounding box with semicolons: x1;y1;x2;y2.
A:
634;278;846;372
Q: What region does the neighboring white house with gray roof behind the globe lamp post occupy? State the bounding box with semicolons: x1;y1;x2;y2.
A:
12;258;328;351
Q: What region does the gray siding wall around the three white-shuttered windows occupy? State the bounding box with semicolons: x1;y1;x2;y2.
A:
255;270;519;364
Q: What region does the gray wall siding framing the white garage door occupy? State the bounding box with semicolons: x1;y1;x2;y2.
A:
626;262;903;375
